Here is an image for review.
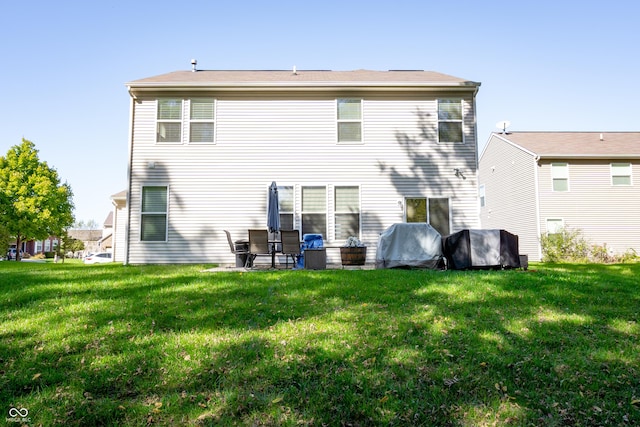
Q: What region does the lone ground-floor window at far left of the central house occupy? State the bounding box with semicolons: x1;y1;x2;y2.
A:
140;186;168;242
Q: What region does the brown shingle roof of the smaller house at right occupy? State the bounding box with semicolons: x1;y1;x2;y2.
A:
493;132;640;158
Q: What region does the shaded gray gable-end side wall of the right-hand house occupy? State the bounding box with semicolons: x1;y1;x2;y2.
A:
478;135;541;261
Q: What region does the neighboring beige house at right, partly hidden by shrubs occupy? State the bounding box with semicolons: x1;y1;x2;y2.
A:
478;132;640;261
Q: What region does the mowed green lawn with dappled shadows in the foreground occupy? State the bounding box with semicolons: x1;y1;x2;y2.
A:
0;262;640;426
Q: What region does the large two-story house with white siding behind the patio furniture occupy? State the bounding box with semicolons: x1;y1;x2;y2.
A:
123;69;480;264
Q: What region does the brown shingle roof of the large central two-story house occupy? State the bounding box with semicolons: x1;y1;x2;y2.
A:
127;70;480;92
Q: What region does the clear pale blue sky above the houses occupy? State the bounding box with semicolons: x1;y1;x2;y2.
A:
0;0;640;223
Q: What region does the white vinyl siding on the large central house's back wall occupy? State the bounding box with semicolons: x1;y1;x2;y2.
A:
128;93;478;264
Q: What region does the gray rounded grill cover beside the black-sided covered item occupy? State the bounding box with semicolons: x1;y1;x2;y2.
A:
376;223;442;268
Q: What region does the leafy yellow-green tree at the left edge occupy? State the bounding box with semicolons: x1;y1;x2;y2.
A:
0;138;74;260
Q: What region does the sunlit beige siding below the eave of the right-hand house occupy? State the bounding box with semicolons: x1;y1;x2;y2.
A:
539;159;640;253
